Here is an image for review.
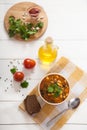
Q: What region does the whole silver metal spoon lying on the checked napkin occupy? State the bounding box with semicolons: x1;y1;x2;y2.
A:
46;98;80;126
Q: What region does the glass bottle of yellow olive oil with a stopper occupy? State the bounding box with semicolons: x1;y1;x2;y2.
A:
38;37;58;64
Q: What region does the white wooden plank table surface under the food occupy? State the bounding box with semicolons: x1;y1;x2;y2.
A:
0;0;87;130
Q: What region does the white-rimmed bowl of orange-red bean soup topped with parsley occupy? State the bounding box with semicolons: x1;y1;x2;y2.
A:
38;73;70;105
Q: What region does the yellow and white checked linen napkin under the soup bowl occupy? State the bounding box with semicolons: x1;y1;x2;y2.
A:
19;57;87;130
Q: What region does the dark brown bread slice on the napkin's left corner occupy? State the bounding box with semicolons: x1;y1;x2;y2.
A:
24;95;41;115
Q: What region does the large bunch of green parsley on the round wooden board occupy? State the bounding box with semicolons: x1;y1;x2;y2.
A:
8;16;43;40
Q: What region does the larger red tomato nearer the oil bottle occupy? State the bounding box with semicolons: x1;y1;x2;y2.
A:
23;58;36;69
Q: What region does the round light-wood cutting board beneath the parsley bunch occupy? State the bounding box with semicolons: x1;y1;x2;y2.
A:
4;2;48;41
